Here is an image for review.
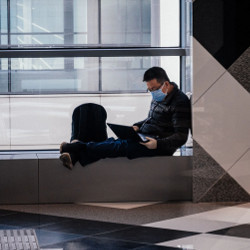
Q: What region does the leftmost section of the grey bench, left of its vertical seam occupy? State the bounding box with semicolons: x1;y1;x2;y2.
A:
0;153;39;204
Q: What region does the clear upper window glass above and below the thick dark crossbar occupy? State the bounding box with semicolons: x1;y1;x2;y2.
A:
0;0;180;94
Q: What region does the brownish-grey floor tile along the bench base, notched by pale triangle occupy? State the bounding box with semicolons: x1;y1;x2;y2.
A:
0;202;240;225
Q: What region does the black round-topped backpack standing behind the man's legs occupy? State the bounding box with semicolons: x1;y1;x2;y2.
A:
70;103;108;142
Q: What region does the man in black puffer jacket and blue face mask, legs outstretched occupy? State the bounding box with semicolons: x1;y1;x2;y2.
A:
60;67;191;169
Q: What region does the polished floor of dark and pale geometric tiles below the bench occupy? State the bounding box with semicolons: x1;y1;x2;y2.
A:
0;202;250;250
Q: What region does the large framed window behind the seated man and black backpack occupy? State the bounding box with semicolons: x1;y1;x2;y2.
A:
0;0;191;149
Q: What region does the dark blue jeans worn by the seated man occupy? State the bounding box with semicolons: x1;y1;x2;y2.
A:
79;137;173;166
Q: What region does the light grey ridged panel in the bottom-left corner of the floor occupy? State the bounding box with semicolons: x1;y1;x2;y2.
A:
0;229;40;250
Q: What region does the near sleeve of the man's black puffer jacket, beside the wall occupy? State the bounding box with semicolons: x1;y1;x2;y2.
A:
157;100;191;152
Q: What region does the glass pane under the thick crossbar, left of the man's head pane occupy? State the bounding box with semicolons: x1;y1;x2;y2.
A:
11;58;99;93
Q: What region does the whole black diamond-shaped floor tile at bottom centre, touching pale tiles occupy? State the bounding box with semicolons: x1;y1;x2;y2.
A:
95;227;195;243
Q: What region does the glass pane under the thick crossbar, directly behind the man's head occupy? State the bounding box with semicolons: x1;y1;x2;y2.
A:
102;57;180;92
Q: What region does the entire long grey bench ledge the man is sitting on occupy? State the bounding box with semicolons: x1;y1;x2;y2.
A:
0;151;192;204
